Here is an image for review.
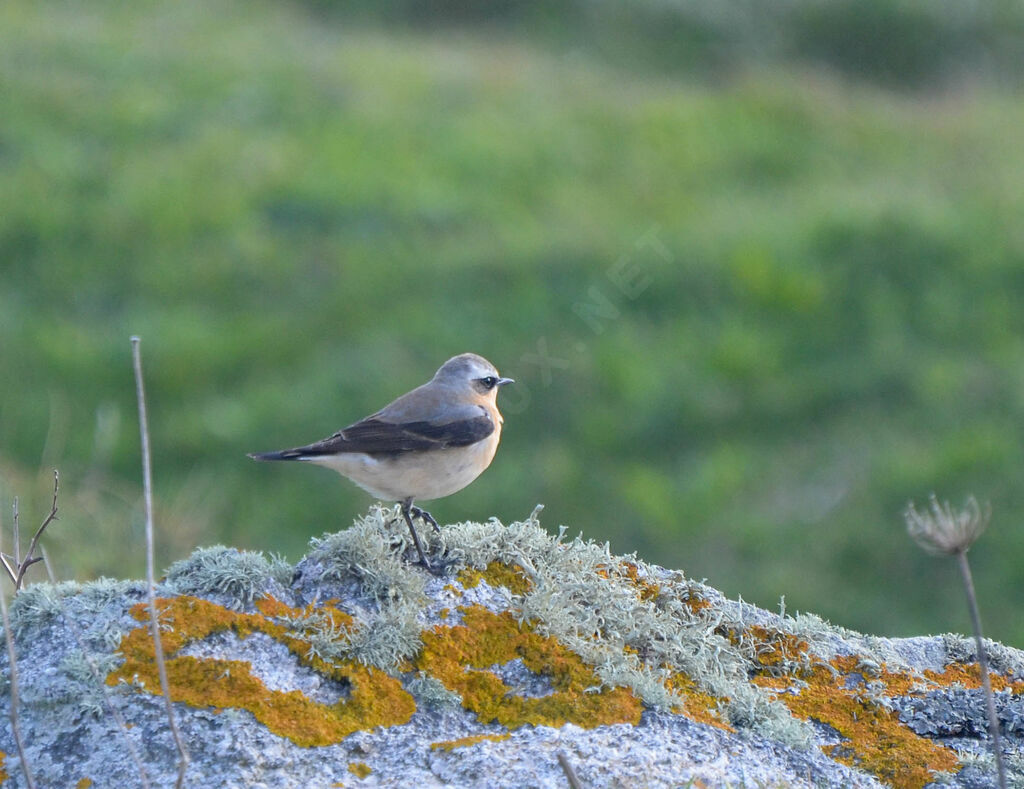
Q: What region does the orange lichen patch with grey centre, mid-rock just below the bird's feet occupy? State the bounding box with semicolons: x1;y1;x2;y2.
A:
417;606;642;729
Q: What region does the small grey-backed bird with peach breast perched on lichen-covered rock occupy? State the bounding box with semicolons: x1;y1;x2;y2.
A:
249;353;513;570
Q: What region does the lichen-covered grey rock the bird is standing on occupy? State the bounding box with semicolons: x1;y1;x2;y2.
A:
0;508;1024;789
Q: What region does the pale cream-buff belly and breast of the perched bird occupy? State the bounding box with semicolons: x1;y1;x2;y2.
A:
308;430;501;501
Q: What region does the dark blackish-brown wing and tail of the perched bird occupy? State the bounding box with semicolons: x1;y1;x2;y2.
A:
254;408;495;461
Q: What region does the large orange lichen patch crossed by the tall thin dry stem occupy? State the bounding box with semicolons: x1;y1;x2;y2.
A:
106;597;416;746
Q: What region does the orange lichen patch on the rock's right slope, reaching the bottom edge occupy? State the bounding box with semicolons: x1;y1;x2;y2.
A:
754;656;958;789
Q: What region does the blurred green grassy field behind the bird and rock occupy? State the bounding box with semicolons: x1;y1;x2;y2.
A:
0;0;1024;646
